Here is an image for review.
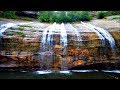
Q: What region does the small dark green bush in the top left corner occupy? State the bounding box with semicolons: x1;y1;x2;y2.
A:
0;11;16;19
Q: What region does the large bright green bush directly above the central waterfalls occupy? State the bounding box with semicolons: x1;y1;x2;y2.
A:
38;11;92;23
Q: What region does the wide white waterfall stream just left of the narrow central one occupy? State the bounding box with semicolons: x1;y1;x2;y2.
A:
40;23;56;70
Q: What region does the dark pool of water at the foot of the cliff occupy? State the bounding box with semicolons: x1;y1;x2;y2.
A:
0;70;120;79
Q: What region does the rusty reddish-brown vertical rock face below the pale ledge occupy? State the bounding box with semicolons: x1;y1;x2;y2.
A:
0;19;120;70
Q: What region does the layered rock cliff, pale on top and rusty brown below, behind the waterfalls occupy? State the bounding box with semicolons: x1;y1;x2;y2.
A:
0;19;120;70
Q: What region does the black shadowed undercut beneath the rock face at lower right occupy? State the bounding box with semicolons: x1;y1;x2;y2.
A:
70;60;120;71
